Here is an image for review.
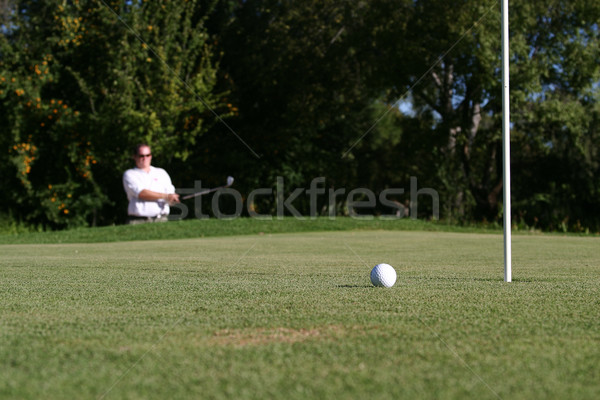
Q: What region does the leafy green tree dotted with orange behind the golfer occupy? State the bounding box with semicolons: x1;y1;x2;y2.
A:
0;1;226;227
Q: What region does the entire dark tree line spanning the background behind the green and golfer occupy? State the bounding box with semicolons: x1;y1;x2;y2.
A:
0;0;600;231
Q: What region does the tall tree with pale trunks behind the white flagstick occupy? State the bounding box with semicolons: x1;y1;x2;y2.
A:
366;0;600;226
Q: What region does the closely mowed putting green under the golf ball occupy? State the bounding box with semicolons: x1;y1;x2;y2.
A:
0;231;600;399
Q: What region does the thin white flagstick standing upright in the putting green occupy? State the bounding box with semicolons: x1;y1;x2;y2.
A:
502;0;512;282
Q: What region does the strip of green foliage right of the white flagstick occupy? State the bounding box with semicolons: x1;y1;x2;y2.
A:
512;1;600;231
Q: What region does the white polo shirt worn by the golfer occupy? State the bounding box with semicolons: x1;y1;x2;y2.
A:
123;166;175;217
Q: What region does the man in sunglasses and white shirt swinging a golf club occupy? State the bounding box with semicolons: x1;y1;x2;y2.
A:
123;144;179;224
